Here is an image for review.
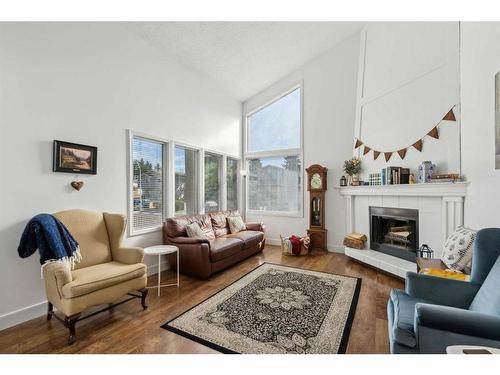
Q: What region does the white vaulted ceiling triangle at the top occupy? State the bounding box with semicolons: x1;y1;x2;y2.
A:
125;22;363;101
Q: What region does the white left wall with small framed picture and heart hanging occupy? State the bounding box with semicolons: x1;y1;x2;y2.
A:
0;23;241;329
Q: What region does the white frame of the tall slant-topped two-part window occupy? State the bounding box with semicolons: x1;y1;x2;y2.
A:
243;81;304;218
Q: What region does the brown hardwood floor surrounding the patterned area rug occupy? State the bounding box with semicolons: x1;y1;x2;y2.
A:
0;246;404;353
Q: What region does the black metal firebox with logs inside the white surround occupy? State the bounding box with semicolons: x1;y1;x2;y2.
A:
369;206;418;262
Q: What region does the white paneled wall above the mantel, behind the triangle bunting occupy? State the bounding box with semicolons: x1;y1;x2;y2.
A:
352;22;460;180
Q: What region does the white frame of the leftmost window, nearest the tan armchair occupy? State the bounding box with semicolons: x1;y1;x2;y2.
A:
127;131;171;237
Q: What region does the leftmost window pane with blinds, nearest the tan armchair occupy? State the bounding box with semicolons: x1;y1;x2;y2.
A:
131;136;166;232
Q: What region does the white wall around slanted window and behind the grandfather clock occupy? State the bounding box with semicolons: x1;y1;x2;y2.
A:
243;35;359;250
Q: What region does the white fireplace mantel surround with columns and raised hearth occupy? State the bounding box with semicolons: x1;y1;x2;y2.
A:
336;182;468;277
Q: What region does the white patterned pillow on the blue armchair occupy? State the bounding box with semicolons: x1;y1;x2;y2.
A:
441;227;476;271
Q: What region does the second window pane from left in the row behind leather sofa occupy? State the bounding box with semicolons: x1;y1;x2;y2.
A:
175;146;198;216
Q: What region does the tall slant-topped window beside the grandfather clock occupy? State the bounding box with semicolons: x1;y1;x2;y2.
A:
245;87;303;216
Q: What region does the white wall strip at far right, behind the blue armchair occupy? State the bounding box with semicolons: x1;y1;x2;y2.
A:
460;22;500;229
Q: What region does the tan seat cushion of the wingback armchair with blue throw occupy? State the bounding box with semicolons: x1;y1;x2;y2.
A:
62;262;146;298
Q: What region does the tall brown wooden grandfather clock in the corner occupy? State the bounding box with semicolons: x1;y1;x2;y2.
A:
306;164;328;251
